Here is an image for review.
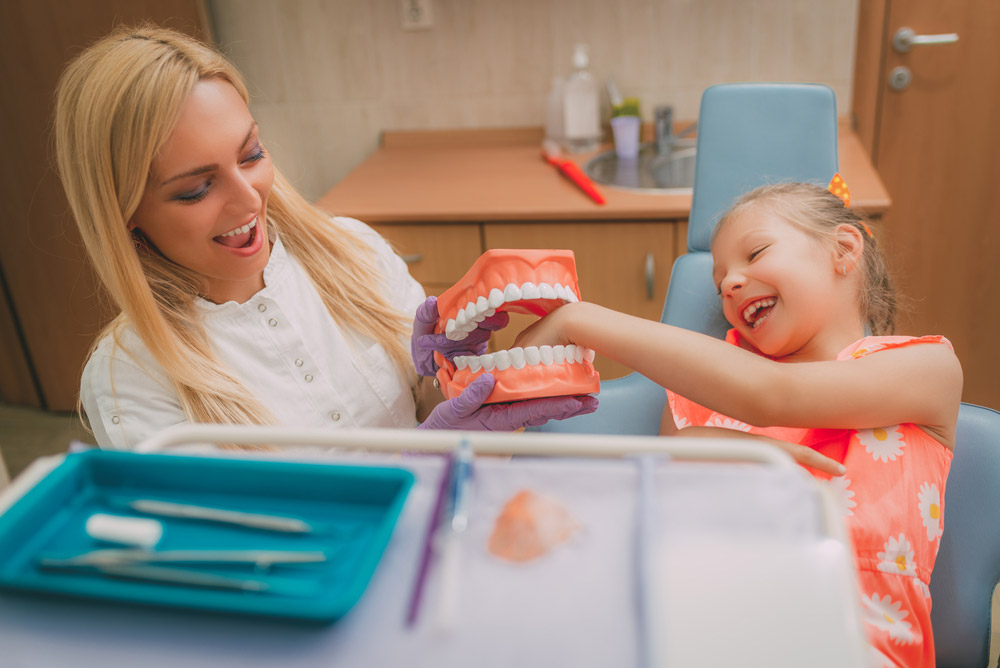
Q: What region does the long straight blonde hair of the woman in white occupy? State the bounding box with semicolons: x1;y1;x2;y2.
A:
55;24;416;424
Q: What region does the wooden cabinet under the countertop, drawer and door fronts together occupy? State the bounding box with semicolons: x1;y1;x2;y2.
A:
372;221;686;378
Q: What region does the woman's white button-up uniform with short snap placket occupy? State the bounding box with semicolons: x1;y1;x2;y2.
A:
81;218;425;449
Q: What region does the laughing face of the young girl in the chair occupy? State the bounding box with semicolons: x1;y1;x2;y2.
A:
712;204;857;360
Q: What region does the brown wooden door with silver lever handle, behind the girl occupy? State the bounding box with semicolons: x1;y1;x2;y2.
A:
854;0;1000;408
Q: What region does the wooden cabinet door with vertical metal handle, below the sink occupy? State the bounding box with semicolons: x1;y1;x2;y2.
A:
484;221;681;379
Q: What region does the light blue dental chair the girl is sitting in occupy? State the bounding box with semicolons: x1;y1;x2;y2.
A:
533;83;1000;668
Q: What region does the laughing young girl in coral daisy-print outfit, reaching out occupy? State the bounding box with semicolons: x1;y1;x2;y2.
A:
515;183;962;668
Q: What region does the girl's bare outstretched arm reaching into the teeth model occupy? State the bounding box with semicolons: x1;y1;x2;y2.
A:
515;302;962;447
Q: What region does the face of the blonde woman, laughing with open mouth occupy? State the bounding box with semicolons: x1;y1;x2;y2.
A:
129;79;274;303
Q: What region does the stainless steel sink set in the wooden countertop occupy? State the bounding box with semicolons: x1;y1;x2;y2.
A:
584;139;696;194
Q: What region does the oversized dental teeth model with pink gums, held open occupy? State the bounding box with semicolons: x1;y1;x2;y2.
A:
434;249;600;403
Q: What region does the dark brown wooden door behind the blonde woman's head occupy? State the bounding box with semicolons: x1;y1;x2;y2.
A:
0;0;209;411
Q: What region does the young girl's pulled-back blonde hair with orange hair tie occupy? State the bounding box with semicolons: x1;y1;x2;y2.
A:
712;183;899;336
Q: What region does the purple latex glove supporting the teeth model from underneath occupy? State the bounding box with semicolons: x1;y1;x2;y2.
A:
417;373;597;431
